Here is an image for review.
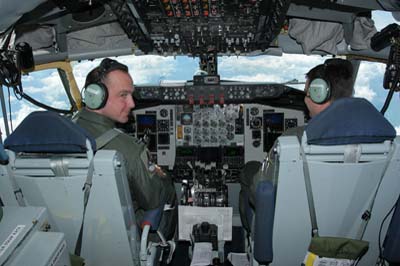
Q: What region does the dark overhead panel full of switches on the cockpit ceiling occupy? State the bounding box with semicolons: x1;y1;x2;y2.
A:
124;0;290;56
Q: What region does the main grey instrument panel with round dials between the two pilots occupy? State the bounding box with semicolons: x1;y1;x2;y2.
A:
134;103;304;182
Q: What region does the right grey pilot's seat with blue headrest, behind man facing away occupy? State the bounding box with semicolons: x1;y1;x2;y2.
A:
245;98;400;266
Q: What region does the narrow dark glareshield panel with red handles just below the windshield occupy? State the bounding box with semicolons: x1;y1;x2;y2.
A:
136;76;304;104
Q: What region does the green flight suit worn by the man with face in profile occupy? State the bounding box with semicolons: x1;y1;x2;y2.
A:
75;109;177;239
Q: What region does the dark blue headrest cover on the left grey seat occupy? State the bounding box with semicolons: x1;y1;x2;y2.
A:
4;111;96;153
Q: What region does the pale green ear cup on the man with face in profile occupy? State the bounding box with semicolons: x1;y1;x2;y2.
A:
83;82;108;110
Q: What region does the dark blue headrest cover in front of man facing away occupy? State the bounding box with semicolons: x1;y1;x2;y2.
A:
305;98;396;145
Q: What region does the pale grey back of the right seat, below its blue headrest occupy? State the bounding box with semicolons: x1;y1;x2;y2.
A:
272;137;400;266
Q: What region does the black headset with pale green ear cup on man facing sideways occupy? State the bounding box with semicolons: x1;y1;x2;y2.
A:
83;58;128;110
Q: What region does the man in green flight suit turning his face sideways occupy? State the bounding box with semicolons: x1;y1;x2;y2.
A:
75;58;177;239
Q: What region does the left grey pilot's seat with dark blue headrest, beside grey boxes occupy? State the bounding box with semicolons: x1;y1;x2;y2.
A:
3;112;140;266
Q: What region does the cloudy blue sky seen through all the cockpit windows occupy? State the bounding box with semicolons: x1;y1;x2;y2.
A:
0;12;400;139
